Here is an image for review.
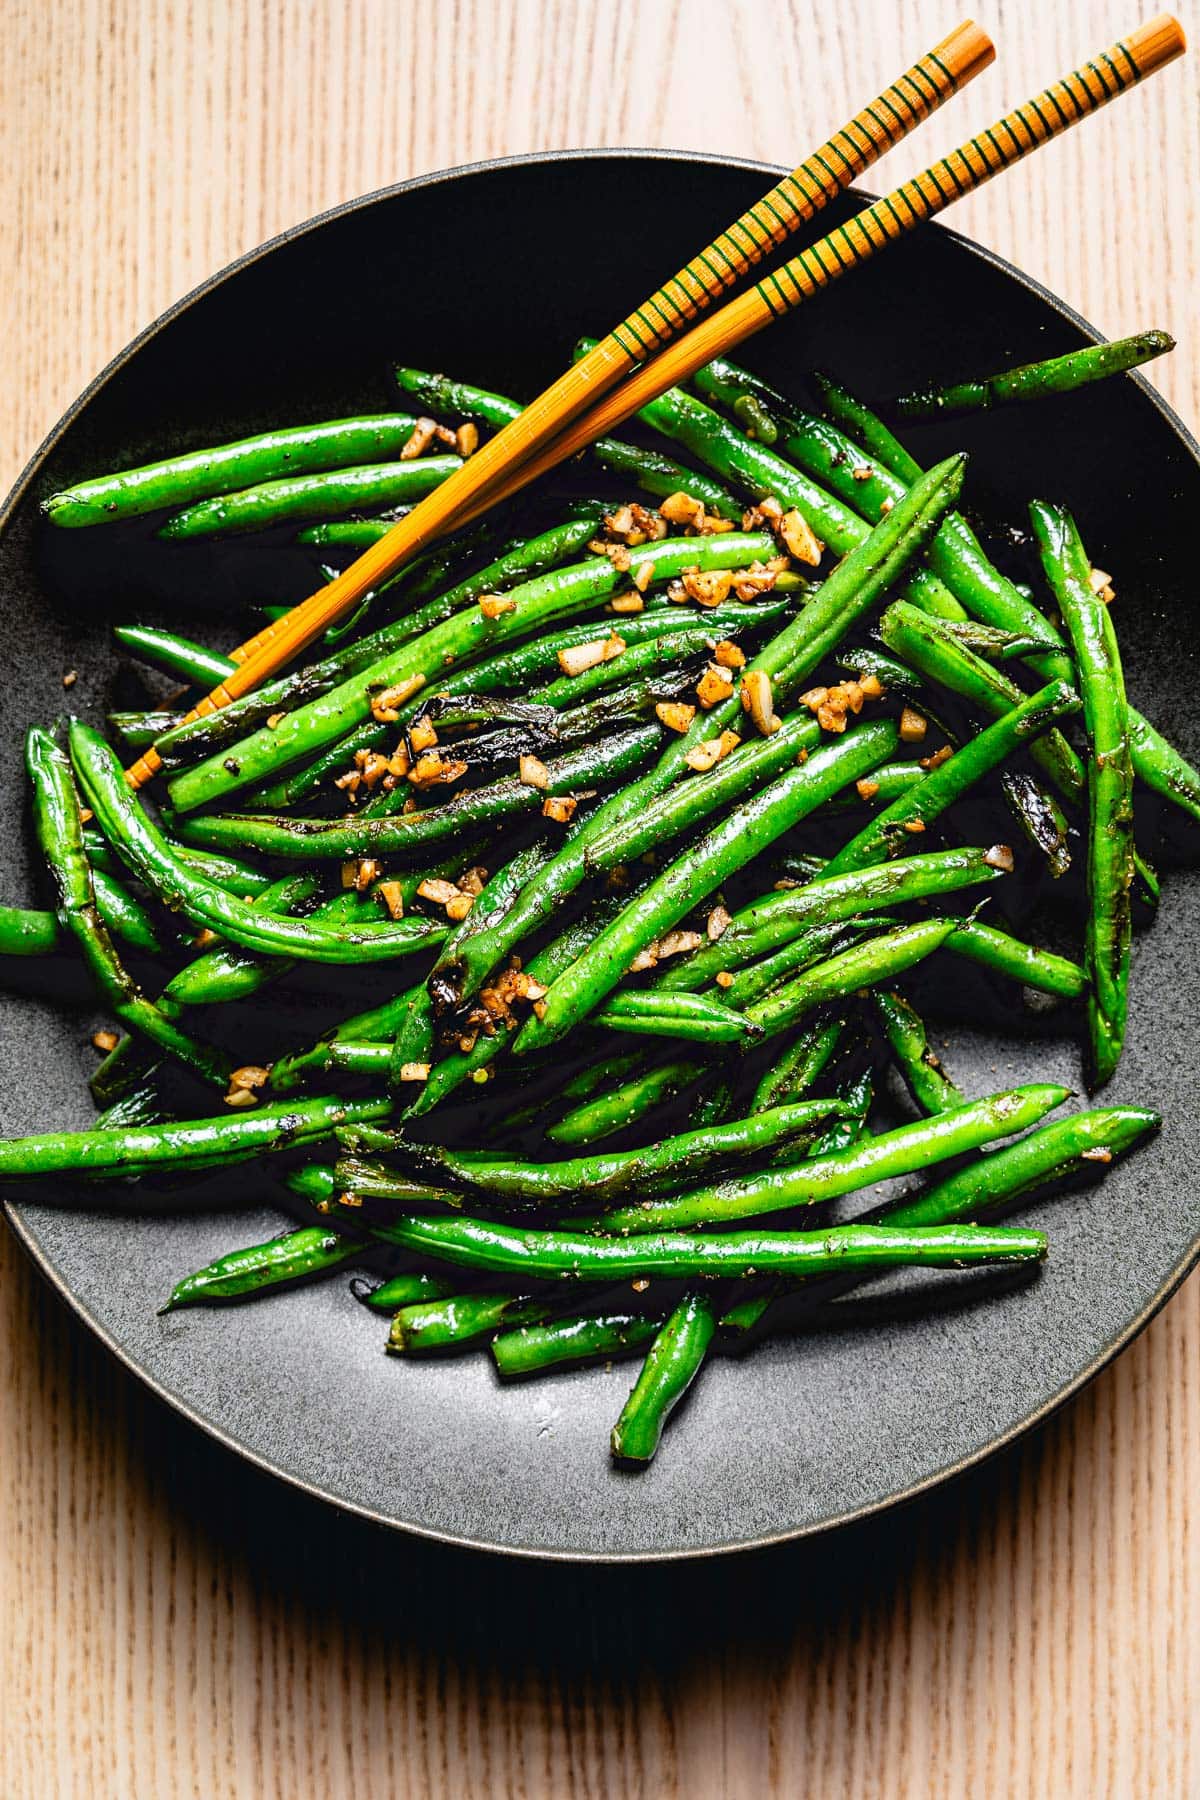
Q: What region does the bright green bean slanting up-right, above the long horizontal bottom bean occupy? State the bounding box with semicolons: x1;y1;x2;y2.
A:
597;1082;1070;1238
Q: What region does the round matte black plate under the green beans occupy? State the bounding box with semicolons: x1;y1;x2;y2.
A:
0;153;1200;1559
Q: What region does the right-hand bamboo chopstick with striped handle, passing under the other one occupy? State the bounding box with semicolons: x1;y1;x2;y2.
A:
459;13;1187;524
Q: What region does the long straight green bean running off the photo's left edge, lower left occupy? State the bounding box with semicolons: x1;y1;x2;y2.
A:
0;1094;392;1206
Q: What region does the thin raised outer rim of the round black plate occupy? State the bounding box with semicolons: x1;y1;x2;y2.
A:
0;146;1200;1566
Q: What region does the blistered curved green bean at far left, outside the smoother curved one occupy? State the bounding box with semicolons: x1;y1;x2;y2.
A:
25;727;230;1089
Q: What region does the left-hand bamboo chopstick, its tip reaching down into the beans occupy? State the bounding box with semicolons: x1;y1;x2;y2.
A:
126;20;995;788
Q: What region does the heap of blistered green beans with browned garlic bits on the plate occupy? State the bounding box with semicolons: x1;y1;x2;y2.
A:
0;343;1200;1467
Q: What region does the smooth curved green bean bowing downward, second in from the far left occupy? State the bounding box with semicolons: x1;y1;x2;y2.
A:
70;720;443;963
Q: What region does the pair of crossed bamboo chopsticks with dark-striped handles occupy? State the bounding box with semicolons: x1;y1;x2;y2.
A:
126;13;1186;788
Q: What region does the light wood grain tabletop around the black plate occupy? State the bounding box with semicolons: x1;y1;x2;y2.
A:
0;0;1200;1800
